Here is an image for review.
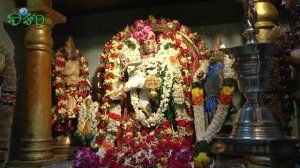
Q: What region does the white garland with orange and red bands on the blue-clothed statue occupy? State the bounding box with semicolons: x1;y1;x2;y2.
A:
192;55;236;142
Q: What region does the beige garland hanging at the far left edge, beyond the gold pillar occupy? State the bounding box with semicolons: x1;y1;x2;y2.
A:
0;41;17;167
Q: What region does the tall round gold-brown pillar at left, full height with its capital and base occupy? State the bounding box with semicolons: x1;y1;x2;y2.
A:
7;0;66;167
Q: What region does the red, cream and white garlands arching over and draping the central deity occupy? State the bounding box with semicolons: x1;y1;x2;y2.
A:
96;18;207;149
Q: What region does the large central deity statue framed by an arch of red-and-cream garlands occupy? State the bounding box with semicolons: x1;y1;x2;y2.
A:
95;17;211;148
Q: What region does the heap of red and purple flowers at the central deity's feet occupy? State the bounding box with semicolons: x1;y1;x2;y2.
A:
73;135;195;168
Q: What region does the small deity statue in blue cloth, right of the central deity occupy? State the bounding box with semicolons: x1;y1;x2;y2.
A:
193;38;236;142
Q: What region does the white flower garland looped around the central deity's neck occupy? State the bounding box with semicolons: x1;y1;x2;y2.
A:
131;38;192;129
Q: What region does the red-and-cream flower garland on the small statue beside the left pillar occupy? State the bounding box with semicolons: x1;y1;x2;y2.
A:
53;50;90;118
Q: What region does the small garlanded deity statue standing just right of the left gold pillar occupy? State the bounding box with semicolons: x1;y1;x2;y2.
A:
52;36;91;144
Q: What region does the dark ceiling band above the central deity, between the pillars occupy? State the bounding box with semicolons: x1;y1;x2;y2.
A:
53;0;243;26
